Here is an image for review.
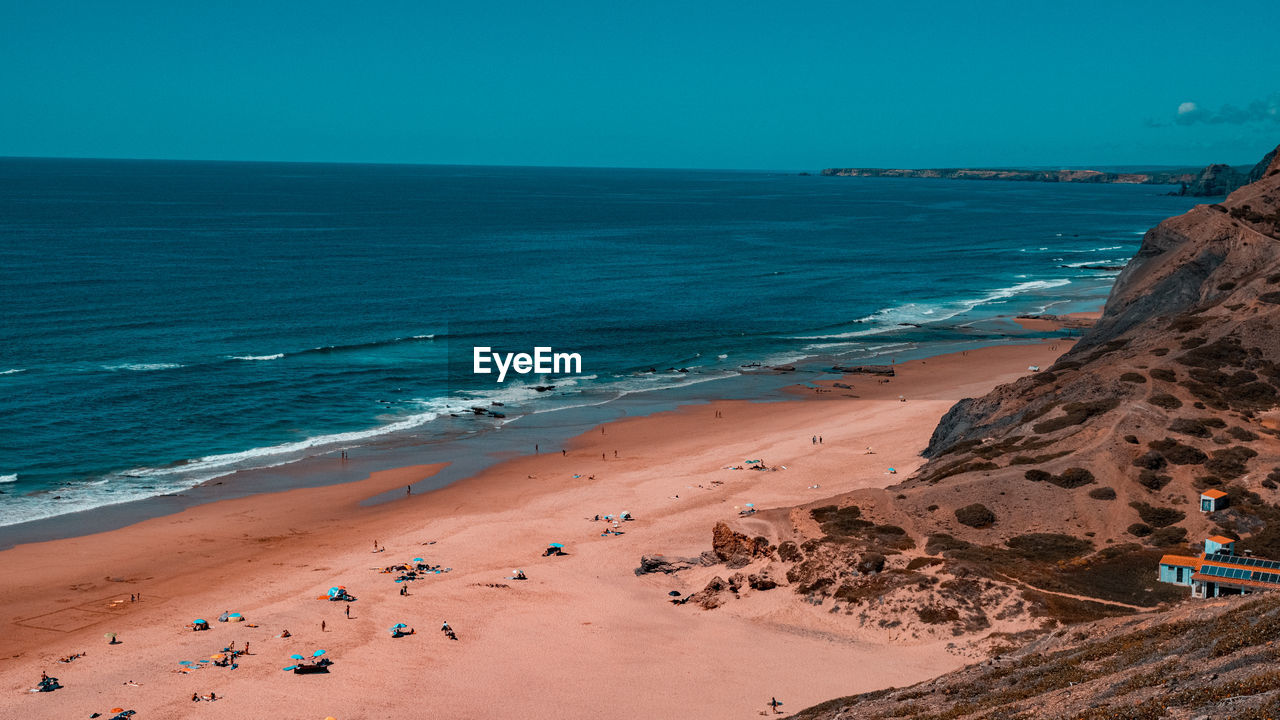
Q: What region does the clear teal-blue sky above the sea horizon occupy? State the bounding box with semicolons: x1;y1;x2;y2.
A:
0;0;1280;169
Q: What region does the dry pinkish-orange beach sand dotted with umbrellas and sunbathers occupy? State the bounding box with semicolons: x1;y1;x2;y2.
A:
0;343;1066;720
